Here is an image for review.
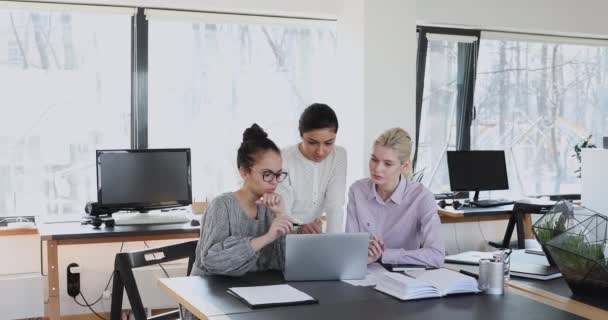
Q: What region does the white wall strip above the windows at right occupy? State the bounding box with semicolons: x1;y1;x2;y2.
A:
416;0;608;38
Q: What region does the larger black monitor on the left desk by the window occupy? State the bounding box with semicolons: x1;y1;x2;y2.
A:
97;149;192;212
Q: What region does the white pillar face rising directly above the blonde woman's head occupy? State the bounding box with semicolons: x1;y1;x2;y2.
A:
363;0;416;165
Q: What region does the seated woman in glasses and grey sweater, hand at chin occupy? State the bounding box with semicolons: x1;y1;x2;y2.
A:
192;124;293;276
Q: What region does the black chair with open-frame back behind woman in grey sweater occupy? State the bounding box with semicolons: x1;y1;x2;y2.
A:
111;240;198;320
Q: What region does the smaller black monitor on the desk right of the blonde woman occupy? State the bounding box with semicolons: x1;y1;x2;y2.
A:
447;150;509;201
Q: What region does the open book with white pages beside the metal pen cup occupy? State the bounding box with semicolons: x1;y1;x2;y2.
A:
375;269;479;300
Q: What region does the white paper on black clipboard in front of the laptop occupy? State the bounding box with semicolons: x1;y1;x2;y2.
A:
228;284;318;309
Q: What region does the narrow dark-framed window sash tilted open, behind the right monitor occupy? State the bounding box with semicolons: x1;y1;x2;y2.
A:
414;28;478;192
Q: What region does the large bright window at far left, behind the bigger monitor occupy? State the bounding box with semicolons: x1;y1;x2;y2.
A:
0;5;131;215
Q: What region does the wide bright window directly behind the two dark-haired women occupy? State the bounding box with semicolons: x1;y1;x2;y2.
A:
146;10;336;200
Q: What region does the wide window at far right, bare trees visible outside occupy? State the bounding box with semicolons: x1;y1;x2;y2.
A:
471;33;608;194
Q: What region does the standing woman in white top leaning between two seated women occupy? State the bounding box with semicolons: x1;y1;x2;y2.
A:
278;103;346;233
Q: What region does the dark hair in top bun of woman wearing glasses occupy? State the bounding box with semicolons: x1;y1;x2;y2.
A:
236;123;281;170
